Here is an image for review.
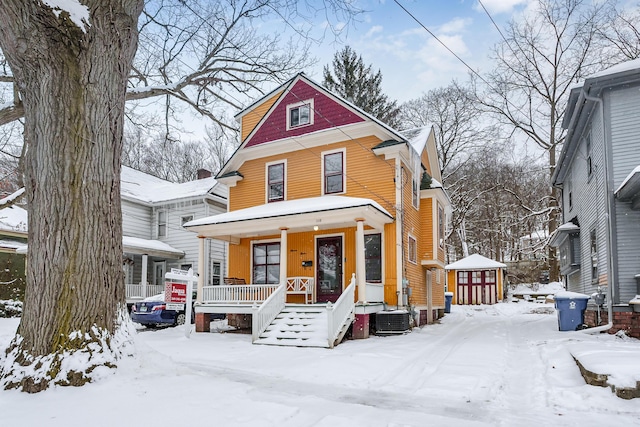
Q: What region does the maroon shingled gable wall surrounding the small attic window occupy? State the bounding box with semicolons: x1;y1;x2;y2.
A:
244;79;365;147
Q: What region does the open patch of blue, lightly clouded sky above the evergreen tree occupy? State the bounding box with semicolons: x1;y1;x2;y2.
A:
308;0;531;102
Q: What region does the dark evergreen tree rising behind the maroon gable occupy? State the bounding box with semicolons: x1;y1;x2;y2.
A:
322;46;400;127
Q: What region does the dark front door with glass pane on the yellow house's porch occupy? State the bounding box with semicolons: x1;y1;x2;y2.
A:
316;236;342;302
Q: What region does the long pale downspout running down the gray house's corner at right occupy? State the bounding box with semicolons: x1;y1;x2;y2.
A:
582;93;615;334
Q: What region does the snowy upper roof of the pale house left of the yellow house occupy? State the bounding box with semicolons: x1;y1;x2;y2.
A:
120;166;224;203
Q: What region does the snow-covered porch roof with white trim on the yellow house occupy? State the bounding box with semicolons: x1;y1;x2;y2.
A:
185;196;393;243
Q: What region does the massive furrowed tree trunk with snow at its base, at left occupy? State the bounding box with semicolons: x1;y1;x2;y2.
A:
0;0;143;392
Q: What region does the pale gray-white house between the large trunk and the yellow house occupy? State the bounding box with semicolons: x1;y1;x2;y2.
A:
120;166;228;304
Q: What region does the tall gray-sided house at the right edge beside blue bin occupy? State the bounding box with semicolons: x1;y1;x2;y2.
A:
551;60;640;338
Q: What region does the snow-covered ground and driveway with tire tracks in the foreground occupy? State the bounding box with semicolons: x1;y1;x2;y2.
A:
0;301;640;427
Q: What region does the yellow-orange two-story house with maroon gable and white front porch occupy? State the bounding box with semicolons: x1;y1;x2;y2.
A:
185;74;450;347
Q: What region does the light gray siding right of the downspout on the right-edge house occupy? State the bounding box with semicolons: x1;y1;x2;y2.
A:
606;87;640;303
